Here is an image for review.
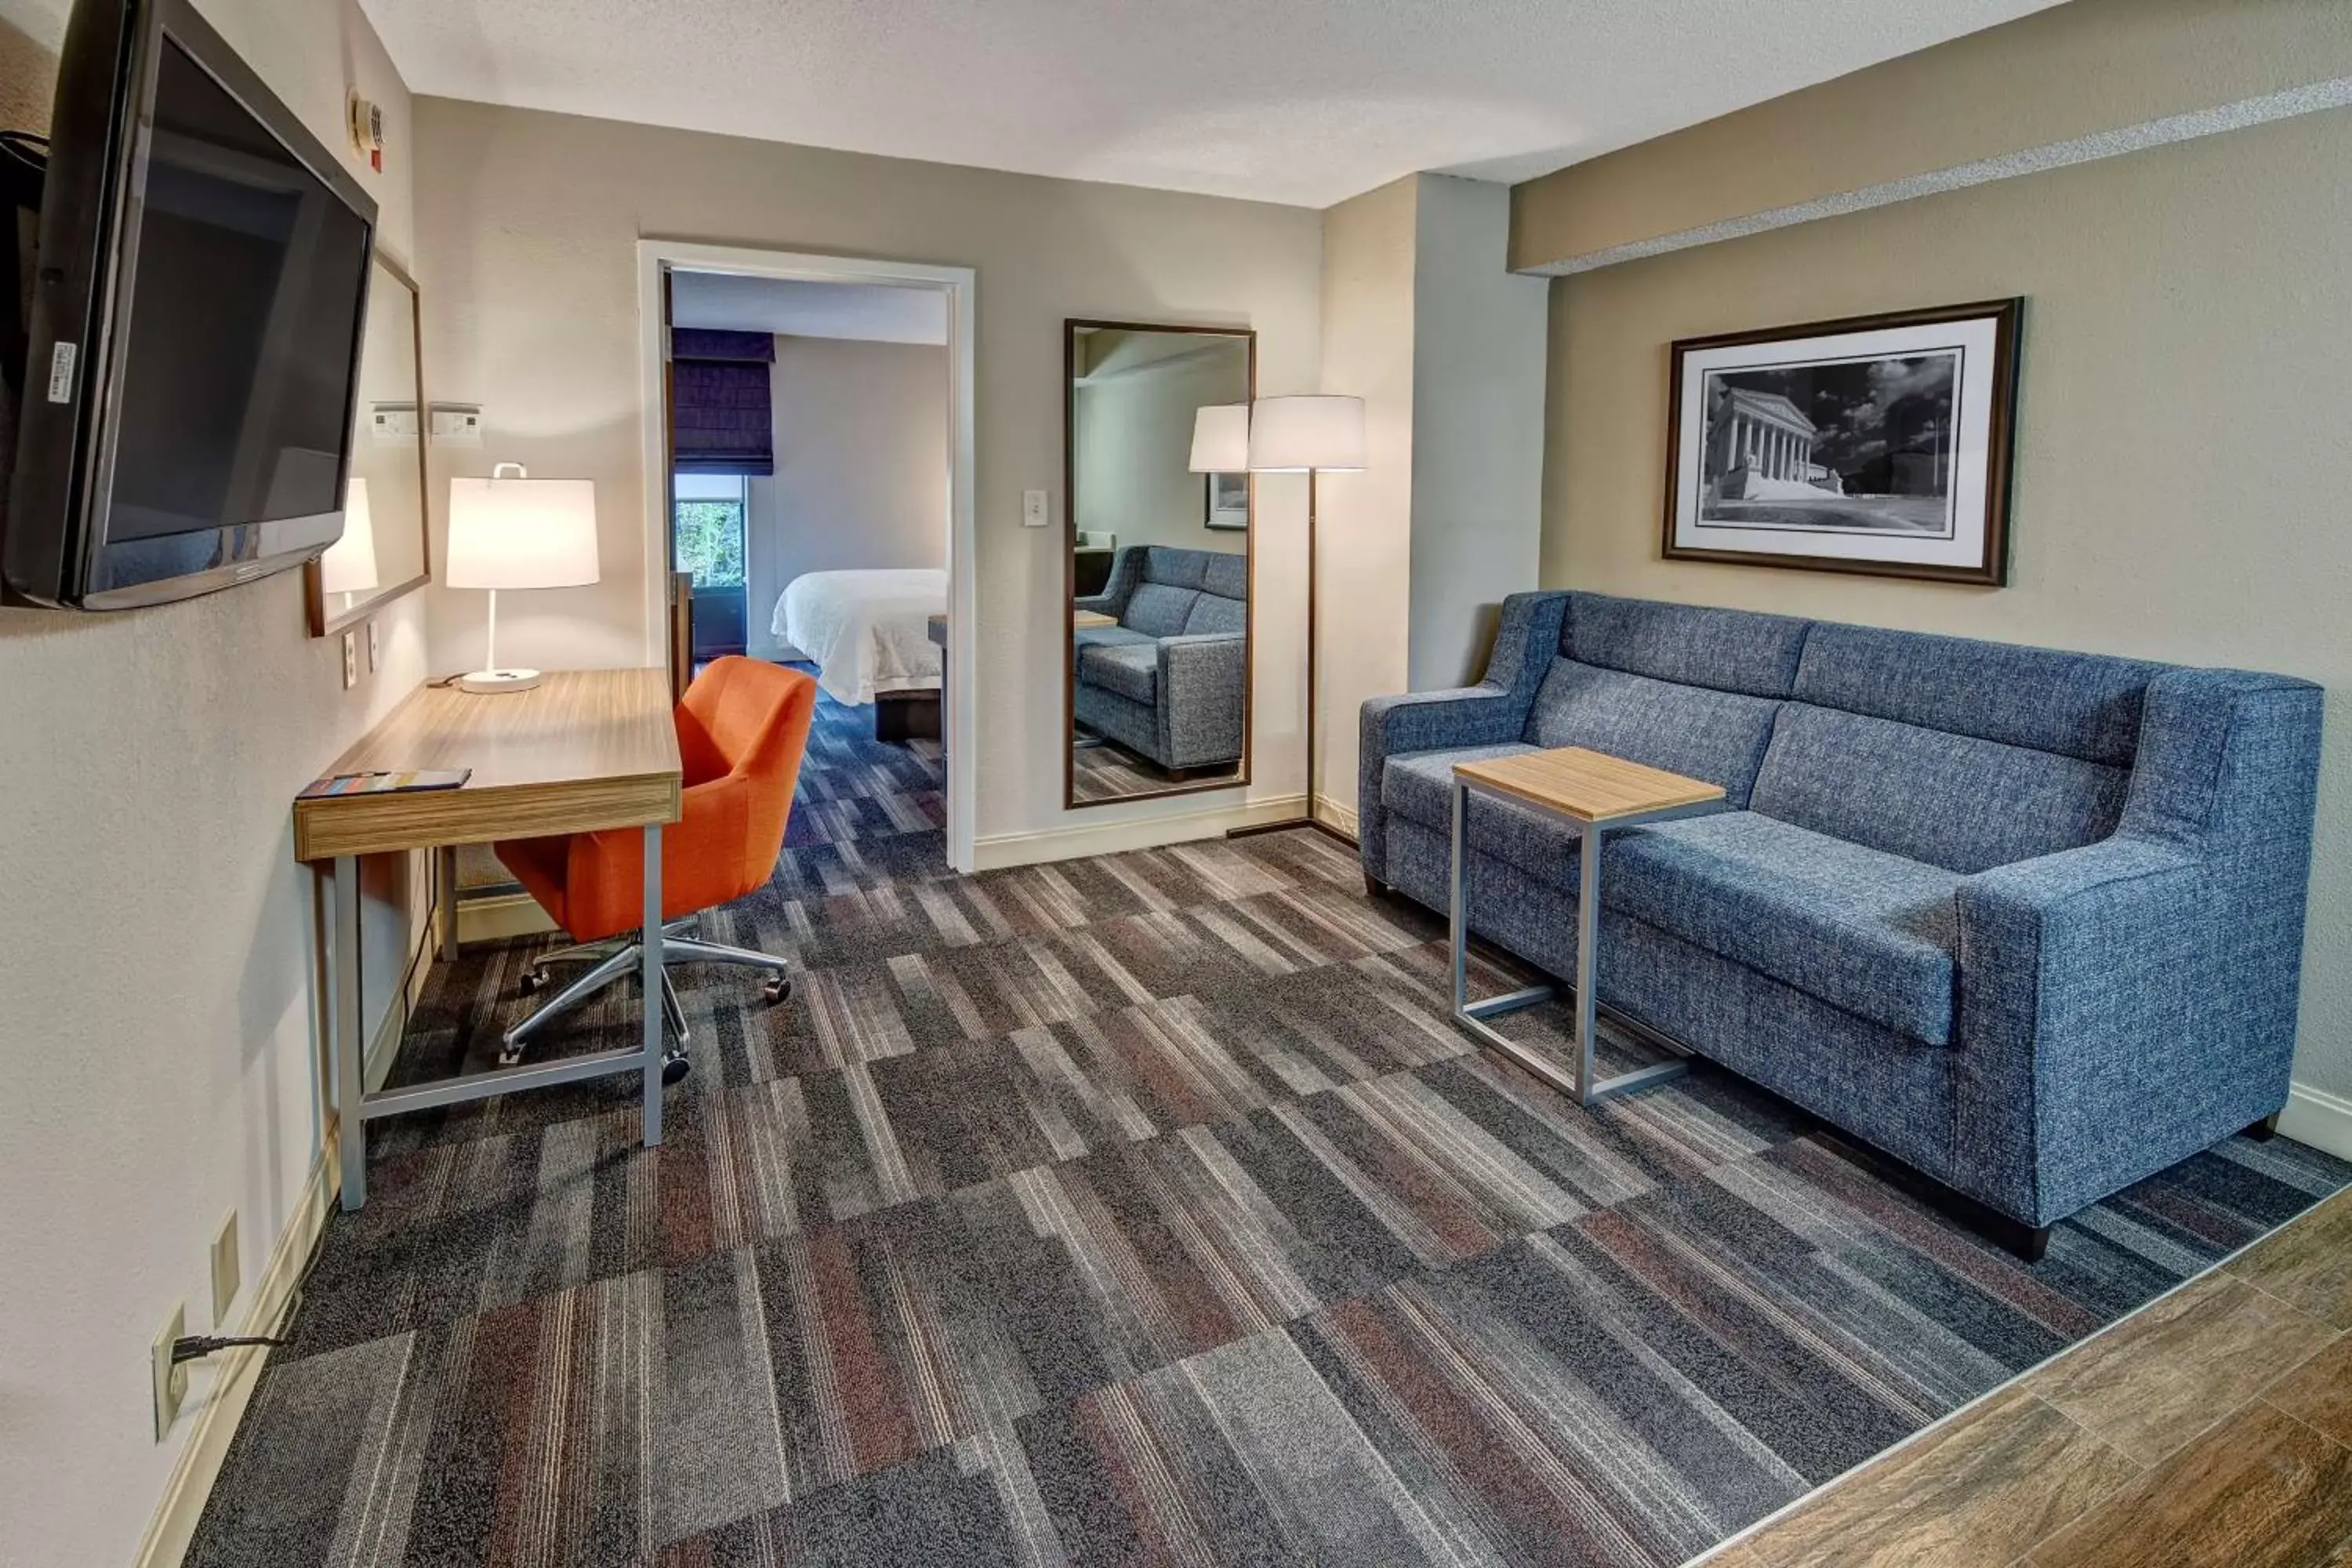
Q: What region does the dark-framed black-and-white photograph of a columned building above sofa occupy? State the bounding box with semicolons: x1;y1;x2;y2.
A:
1665;299;2020;586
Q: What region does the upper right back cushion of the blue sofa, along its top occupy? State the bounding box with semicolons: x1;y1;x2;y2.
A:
1792;621;2171;767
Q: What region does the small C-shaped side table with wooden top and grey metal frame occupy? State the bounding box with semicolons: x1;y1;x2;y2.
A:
1446;746;1724;1105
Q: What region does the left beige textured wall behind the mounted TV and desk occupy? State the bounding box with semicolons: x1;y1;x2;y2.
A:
0;0;433;1563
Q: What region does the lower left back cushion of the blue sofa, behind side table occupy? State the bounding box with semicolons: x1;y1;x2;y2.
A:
1526;659;1780;808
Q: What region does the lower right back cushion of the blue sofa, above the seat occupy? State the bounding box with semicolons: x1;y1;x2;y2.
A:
1748;696;2131;874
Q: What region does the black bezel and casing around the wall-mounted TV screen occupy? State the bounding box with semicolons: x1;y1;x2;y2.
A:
0;0;376;609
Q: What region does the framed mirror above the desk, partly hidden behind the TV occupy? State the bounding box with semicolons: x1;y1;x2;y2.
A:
303;252;430;637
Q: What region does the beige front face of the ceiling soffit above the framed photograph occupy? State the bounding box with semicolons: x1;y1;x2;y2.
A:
1510;0;2352;268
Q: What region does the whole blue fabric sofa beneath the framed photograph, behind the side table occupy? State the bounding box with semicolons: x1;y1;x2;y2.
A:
1357;593;2321;1253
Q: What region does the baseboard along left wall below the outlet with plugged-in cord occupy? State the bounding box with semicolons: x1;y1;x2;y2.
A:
132;1133;339;1568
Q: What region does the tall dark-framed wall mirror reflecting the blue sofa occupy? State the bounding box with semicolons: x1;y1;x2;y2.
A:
1063;322;1258;806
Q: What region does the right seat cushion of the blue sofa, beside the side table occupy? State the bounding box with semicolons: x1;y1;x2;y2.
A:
1602;811;1959;1046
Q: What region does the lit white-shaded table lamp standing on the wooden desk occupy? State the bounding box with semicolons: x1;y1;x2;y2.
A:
445;463;600;694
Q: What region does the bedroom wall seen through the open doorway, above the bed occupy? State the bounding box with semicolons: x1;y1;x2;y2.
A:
746;336;948;649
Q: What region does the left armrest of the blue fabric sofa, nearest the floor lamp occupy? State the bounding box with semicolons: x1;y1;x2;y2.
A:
1355;593;1569;881
